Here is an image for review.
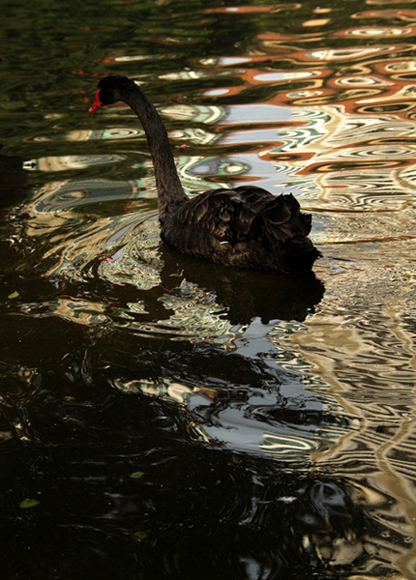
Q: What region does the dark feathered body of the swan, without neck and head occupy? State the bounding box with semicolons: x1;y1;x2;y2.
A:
162;186;320;272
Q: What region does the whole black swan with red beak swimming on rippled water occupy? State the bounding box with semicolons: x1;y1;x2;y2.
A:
89;76;321;273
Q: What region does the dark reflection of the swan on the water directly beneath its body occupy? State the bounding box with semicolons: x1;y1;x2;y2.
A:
100;244;324;325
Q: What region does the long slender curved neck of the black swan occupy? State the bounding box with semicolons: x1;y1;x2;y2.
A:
120;82;188;223
